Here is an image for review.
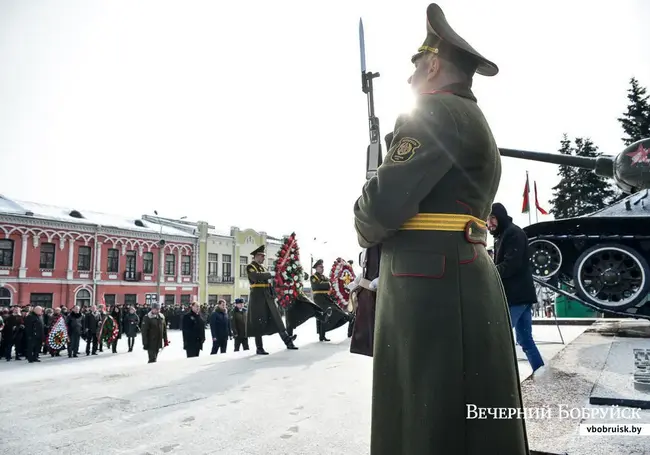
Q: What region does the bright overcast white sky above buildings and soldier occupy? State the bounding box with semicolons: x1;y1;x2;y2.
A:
0;0;650;259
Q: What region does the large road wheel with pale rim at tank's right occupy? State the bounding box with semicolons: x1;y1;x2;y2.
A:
573;245;650;311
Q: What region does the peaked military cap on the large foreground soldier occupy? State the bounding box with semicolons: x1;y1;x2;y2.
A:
411;3;499;76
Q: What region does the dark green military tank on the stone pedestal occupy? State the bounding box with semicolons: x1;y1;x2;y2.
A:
499;139;650;319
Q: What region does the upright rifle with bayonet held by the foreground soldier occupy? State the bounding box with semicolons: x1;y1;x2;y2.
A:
350;19;390;357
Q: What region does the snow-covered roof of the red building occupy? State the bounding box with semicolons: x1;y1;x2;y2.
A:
0;195;196;238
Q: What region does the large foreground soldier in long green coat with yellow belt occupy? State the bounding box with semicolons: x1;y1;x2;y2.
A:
354;4;528;455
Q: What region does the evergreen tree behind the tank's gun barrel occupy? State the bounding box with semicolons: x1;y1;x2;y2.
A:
551;134;617;218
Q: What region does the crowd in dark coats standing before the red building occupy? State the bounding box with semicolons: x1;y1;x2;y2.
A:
0;299;258;363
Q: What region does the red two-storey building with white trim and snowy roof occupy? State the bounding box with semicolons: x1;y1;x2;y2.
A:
0;195;198;307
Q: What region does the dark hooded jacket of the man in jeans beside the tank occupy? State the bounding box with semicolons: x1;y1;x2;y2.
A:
492;203;537;306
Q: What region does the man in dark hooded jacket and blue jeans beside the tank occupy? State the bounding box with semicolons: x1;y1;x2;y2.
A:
488;202;544;372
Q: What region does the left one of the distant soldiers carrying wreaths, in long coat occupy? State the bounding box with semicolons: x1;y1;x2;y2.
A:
246;245;298;355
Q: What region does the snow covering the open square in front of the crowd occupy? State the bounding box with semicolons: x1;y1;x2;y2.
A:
0;321;585;455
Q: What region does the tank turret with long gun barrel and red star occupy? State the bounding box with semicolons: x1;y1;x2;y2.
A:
499;139;650;193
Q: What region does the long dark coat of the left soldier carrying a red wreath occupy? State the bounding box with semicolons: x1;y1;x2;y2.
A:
246;262;286;337
